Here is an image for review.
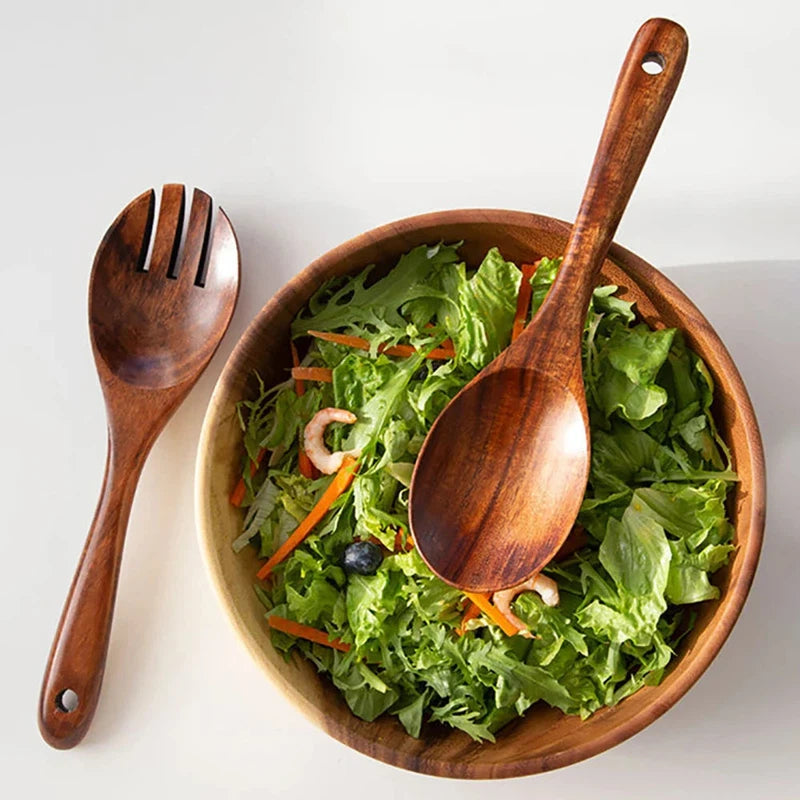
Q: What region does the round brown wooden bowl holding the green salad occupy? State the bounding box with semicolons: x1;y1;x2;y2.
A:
196;210;765;778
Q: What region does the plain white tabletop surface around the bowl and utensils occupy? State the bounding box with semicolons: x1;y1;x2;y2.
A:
0;0;800;800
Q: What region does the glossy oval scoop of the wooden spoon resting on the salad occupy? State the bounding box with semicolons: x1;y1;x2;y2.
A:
410;366;589;592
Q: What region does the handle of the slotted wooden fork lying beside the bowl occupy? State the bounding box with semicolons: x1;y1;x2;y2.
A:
39;435;149;749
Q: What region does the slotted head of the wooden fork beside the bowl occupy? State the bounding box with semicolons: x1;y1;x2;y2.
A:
89;184;240;389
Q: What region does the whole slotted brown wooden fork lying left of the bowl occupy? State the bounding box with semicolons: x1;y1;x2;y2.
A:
39;184;239;749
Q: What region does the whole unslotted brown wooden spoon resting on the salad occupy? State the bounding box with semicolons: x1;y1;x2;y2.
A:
410;19;688;592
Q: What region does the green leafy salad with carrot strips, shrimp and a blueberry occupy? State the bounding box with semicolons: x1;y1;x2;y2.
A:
231;243;736;741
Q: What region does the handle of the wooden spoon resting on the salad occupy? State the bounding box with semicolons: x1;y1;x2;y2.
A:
539;19;689;322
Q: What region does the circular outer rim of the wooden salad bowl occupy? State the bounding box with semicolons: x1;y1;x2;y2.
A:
194;208;766;779
